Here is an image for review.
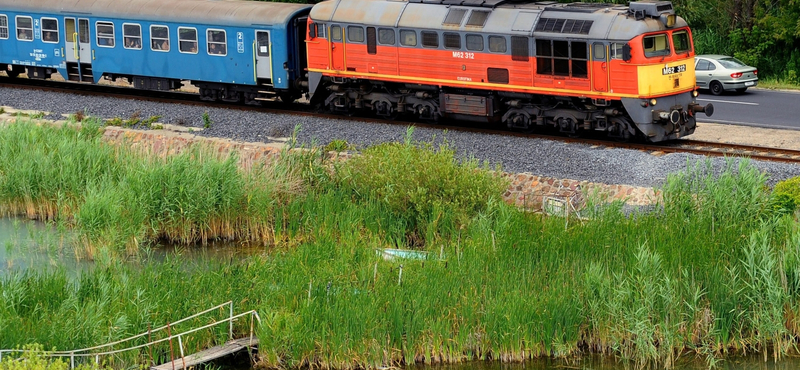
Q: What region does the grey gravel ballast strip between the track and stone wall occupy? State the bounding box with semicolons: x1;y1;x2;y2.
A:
0;88;800;187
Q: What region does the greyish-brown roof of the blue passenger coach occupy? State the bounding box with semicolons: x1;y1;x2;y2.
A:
0;0;311;26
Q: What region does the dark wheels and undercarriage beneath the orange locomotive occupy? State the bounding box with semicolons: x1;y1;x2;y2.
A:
324;79;637;139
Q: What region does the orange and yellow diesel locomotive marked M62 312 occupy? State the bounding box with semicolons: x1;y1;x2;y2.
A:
306;0;713;142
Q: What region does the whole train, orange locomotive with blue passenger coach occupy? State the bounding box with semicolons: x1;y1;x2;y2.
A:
0;0;714;142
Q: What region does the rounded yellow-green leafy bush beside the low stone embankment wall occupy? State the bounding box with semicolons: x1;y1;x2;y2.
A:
338;128;508;245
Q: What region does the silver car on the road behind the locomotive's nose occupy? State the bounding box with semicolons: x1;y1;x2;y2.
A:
694;55;758;95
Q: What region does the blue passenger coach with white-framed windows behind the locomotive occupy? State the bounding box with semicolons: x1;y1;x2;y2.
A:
0;0;311;103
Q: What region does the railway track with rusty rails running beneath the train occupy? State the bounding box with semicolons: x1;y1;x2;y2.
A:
0;77;800;163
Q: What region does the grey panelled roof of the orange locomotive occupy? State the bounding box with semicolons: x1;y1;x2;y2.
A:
311;0;686;40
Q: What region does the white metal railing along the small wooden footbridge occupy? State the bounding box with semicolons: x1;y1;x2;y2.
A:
0;301;261;369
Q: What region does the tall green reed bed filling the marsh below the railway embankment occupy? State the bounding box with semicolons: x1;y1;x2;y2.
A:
0;119;800;369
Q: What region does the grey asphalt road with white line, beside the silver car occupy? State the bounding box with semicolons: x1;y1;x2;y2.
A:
697;89;800;130
